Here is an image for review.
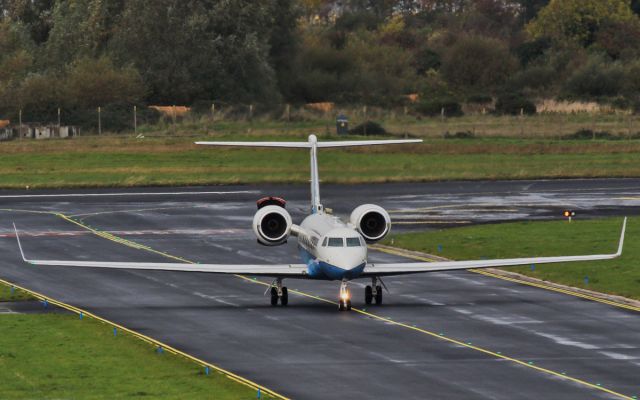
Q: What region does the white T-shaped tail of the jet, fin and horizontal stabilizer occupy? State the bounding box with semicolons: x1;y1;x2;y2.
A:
196;135;422;214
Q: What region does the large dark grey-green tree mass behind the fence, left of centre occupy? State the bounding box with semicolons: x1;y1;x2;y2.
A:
111;0;278;103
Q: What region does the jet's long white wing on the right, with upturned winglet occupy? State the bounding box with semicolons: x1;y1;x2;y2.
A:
362;218;627;277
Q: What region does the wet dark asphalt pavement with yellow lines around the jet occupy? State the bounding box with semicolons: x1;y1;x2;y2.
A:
0;179;640;399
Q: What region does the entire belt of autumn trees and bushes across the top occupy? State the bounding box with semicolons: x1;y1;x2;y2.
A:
0;0;640;127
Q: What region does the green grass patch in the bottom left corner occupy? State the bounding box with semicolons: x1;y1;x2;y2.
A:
0;308;268;400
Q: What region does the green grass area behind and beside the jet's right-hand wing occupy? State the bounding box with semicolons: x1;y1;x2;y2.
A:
387;218;640;299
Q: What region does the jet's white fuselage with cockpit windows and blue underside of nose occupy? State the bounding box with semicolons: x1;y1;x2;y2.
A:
298;212;367;280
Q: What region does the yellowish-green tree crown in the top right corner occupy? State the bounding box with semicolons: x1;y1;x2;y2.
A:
527;0;638;46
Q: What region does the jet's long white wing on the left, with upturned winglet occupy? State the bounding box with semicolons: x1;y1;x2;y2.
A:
13;224;307;278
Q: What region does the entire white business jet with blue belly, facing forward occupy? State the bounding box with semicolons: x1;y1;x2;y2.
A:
14;135;627;311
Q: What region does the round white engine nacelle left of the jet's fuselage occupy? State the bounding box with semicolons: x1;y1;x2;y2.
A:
253;205;293;246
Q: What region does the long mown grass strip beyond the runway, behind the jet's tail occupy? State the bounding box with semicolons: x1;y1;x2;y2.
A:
0;134;640;188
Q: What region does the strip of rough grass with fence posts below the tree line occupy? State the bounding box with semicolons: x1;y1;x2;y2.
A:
0;101;640;140
